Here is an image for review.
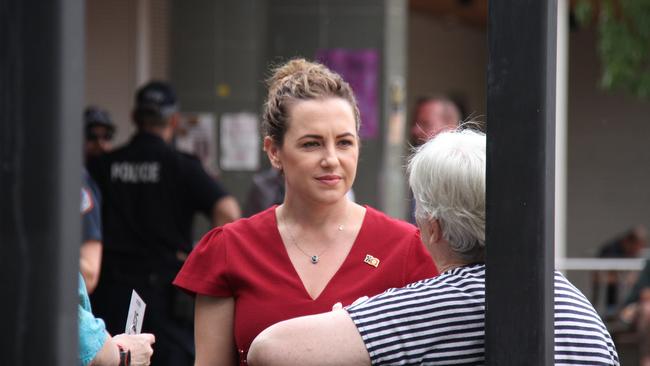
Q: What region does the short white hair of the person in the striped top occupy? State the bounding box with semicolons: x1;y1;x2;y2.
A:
408;129;485;263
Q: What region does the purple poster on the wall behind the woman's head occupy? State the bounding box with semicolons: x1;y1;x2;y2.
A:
316;48;379;139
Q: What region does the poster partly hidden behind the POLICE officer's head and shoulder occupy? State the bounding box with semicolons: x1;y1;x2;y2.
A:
174;112;219;175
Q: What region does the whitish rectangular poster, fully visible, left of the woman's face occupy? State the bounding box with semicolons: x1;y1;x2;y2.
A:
219;112;260;171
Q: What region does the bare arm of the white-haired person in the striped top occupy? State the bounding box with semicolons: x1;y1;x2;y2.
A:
248;310;370;366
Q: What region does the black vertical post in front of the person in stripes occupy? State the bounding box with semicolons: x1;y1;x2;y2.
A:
485;0;557;366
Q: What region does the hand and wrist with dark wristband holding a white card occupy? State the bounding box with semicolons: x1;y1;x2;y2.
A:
90;333;155;366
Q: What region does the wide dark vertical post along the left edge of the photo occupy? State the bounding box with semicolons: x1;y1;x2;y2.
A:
0;0;84;366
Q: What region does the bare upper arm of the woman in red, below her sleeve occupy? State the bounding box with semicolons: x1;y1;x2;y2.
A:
194;295;237;366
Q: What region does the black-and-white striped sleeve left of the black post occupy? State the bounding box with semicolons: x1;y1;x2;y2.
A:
348;269;485;365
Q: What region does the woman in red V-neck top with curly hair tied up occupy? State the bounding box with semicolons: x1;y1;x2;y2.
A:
174;59;437;365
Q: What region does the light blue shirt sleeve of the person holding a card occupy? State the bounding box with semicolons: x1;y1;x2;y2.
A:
79;273;108;366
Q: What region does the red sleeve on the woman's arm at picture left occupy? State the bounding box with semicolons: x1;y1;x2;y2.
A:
173;227;233;297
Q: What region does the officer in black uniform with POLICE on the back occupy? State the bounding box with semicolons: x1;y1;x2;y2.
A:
88;81;240;366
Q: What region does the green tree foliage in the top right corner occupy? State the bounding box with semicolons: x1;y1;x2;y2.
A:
574;0;650;99
